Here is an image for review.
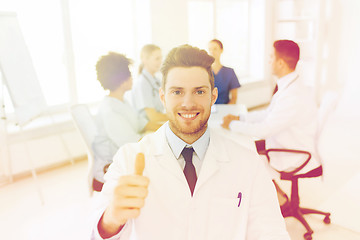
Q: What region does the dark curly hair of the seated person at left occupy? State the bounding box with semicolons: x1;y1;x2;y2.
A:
96;52;132;91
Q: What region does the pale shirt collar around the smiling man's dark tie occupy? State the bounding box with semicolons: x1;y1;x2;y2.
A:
165;122;210;160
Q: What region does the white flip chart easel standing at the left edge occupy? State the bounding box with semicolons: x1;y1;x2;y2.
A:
0;11;73;204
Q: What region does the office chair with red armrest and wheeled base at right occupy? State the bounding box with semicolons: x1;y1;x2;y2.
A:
255;92;338;240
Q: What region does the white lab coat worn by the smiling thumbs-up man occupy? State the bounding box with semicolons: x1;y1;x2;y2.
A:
93;126;290;240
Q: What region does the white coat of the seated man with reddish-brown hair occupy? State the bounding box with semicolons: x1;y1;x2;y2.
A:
229;72;320;173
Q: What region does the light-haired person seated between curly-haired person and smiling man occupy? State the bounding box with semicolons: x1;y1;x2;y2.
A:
132;44;168;122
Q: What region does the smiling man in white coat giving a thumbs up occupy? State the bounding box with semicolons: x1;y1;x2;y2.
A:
92;45;290;240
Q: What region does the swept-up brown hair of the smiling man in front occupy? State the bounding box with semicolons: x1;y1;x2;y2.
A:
161;44;214;90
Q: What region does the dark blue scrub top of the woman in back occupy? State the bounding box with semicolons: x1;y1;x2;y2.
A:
213;66;240;104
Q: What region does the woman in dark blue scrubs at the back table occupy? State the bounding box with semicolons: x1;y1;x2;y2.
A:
209;39;240;104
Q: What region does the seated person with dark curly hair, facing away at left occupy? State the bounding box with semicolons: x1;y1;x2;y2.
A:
92;52;160;191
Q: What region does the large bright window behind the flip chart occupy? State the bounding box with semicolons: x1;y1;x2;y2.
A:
0;0;151;113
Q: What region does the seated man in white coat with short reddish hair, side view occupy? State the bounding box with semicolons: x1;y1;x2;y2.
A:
222;40;319;208
